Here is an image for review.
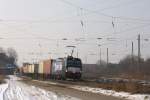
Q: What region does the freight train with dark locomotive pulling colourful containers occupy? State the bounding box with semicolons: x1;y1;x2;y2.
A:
20;56;82;80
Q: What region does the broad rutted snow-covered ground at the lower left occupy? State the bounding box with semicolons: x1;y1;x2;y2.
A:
0;76;79;100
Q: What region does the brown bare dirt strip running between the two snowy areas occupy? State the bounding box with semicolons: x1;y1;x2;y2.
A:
20;78;126;100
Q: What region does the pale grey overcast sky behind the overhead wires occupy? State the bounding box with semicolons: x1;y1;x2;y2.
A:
0;0;150;64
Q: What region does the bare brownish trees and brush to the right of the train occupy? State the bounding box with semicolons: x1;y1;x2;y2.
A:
97;55;150;79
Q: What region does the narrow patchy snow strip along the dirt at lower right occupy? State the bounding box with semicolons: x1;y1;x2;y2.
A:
70;86;150;100
